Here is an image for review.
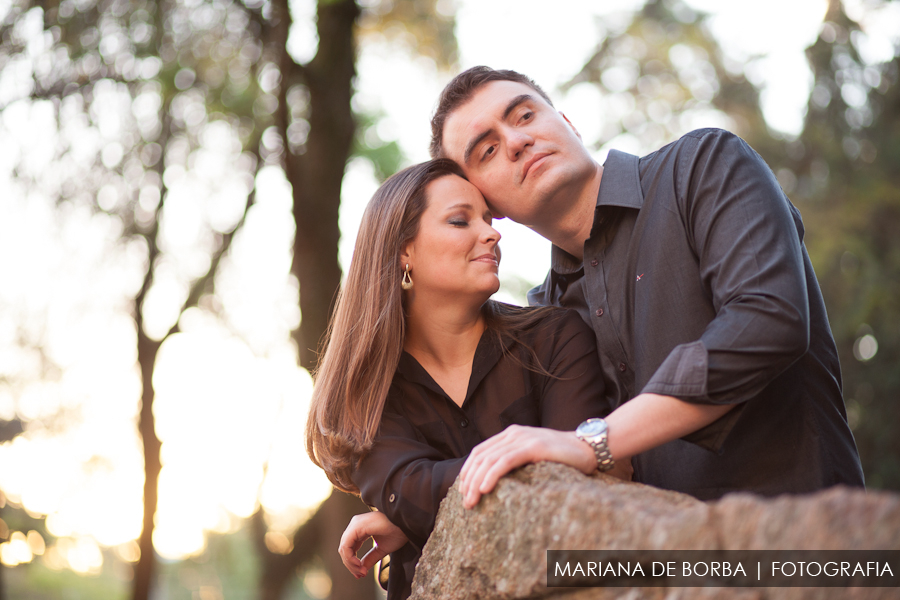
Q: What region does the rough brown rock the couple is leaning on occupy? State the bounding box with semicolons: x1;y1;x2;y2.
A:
412;463;900;600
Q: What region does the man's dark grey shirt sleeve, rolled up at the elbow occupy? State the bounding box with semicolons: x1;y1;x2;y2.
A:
643;131;809;404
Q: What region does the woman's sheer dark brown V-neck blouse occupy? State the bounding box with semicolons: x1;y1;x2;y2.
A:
353;307;611;600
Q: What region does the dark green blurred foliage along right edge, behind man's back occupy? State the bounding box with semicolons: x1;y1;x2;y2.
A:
783;2;900;490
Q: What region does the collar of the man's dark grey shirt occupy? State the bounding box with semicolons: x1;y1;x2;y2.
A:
550;150;644;275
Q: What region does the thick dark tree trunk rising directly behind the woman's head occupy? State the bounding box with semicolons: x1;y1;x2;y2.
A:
254;0;376;600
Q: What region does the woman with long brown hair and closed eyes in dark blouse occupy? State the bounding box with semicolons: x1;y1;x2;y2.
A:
306;160;610;599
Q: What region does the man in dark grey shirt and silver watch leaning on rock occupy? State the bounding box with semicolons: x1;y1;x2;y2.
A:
345;67;863;580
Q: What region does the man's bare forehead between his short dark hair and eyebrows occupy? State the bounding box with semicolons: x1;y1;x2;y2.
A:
443;80;541;163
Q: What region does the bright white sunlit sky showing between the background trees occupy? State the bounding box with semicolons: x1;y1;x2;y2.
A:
0;0;900;576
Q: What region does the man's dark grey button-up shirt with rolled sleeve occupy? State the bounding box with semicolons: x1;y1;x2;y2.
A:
529;129;863;499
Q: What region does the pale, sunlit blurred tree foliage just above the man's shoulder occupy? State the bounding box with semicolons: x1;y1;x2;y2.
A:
562;0;771;150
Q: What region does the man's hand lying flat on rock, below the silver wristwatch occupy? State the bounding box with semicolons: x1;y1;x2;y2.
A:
459;425;597;508
